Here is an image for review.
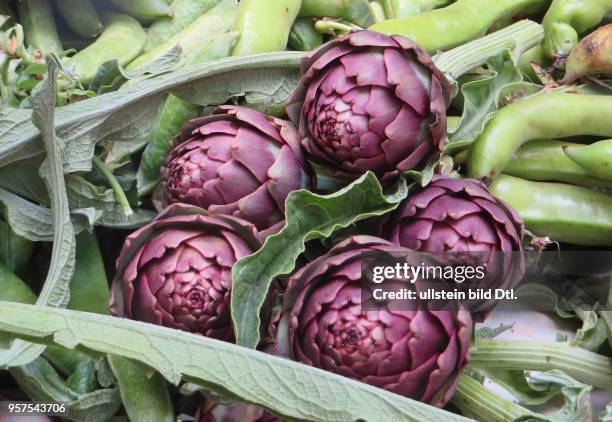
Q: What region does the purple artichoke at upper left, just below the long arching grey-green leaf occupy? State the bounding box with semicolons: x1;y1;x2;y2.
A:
161;106;313;230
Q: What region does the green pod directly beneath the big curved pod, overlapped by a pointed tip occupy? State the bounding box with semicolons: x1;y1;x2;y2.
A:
504;139;612;188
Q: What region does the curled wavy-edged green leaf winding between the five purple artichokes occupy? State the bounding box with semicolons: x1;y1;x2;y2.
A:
231;172;408;348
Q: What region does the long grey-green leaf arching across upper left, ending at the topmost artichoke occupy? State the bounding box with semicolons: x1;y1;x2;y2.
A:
0;52;303;172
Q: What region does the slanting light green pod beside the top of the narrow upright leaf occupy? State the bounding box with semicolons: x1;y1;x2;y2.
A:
67;13;146;84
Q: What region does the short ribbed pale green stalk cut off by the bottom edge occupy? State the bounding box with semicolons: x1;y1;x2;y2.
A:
451;373;534;422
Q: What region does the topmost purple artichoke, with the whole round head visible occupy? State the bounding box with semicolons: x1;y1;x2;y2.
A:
287;31;451;180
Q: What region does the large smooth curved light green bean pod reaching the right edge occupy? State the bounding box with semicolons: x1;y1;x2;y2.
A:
468;93;612;179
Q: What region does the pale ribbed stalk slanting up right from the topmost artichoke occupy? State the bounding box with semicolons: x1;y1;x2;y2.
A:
434;20;544;81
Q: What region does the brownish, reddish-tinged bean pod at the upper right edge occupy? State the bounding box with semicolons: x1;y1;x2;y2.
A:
561;23;612;84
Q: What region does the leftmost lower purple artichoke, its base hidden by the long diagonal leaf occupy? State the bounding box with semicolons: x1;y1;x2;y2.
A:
110;204;260;341
